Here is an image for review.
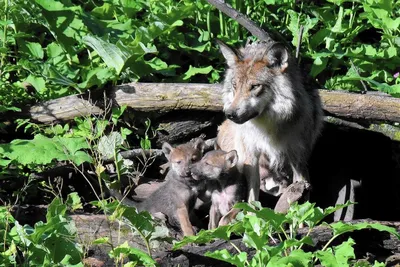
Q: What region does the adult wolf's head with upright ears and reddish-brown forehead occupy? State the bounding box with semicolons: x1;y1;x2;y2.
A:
218;42;294;124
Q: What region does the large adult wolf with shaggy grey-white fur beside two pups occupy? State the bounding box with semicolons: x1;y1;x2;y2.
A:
217;41;322;201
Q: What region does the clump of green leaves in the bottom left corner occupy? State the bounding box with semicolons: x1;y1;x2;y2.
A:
0;194;83;267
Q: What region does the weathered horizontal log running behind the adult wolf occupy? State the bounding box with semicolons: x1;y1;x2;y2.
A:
18;83;400;123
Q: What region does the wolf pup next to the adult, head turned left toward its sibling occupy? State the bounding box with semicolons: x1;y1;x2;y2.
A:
191;150;247;229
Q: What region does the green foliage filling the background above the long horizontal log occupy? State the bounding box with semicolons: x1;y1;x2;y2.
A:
0;0;400;111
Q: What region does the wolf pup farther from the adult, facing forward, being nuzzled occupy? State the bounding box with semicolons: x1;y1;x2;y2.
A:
111;138;205;236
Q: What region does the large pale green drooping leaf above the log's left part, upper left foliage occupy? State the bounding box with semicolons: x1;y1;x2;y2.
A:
82;35;132;74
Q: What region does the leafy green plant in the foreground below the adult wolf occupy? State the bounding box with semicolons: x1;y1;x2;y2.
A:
174;202;400;267
